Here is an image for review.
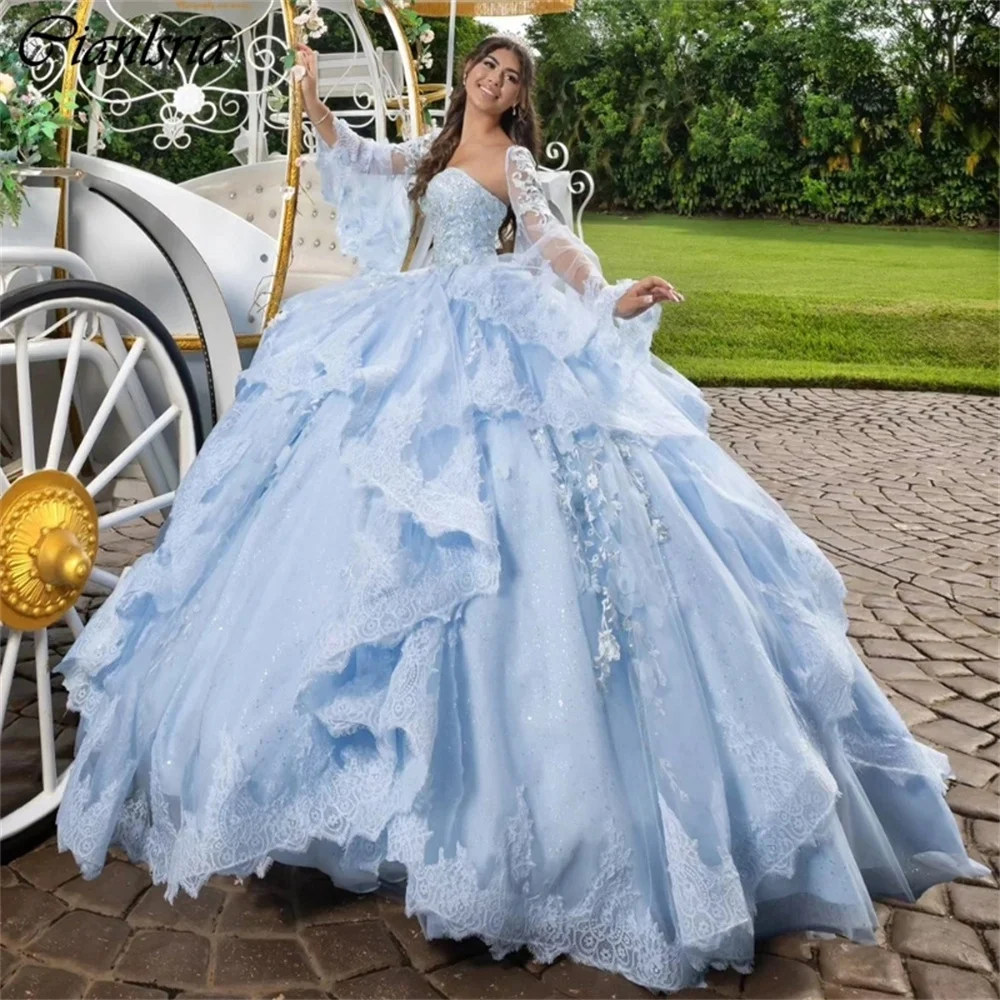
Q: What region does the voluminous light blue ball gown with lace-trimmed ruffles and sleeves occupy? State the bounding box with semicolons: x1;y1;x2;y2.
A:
52;119;985;990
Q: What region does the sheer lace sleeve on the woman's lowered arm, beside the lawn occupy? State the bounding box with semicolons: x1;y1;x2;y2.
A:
507;146;662;368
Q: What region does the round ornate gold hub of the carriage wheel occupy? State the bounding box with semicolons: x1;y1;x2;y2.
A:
0;469;98;631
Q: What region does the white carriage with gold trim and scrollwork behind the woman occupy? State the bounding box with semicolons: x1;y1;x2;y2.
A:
0;0;592;840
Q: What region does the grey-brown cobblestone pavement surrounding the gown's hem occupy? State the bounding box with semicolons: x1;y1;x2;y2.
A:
0;389;1000;1000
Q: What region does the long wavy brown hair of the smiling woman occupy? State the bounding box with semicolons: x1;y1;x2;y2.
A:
410;35;542;251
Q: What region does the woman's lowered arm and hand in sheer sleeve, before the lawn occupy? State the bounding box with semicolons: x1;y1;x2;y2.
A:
507;146;684;319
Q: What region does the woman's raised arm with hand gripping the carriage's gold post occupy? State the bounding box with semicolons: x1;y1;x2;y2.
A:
296;45;434;174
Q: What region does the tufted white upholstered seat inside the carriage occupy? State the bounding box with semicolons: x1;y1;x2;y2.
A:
181;157;357;298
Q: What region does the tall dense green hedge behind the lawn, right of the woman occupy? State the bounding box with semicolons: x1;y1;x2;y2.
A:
530;0;1000;225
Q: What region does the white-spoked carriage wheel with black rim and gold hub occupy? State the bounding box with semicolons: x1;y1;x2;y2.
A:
0;280;202;847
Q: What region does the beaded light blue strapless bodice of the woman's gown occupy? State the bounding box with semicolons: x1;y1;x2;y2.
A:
420;167;507;267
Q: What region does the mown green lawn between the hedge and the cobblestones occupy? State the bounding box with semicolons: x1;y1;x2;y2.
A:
584;214;1000;393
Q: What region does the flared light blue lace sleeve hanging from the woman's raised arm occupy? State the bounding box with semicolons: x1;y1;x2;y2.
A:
316;118;439;271
